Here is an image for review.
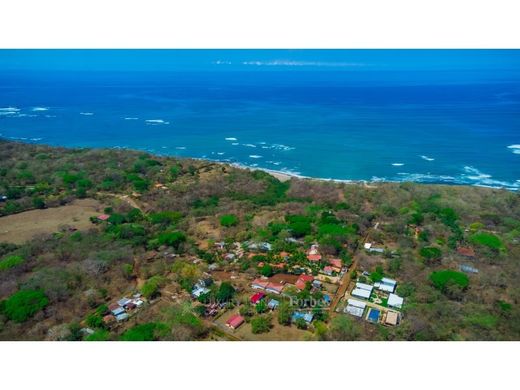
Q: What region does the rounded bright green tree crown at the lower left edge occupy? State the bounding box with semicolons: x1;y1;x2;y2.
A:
2;290;49;322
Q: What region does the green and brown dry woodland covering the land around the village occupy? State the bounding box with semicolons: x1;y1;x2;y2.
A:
0;141;520;340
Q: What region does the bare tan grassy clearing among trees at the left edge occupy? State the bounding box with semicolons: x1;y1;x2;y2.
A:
0;199;103;244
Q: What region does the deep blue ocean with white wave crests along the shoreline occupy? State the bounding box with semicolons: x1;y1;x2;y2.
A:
0;51;520;190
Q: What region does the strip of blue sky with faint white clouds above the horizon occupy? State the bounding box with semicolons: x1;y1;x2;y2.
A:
0;50;520;71
